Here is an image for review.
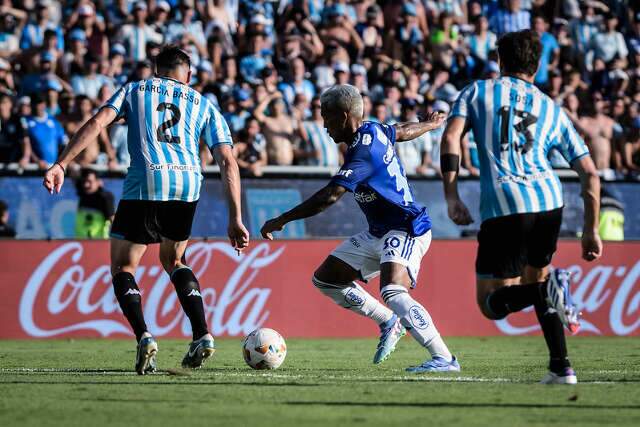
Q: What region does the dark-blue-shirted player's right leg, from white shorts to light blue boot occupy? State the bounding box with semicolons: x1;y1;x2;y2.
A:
380;231;460;372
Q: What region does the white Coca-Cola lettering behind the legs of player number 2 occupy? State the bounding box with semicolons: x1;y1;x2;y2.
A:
19;242;285;337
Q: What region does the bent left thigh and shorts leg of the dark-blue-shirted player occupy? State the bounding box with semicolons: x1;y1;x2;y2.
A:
316;231;380;283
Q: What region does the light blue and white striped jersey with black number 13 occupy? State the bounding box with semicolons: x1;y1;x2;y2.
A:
451;77;589;221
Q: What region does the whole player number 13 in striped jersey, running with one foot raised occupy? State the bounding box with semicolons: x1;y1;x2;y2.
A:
440;30;602;384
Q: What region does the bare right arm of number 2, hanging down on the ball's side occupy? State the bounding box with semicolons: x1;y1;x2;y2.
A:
211;144;249;251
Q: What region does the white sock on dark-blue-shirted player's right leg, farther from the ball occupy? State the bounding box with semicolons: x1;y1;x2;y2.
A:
380;284;452;360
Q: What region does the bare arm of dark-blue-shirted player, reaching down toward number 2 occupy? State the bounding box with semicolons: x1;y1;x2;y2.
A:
260;184;347;240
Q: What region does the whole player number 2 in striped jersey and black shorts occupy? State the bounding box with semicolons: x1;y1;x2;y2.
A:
44;46;249;375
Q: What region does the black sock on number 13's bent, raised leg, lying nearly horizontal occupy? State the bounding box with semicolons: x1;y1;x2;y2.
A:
486;283;546;319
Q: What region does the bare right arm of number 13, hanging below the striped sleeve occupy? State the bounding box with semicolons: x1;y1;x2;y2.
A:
571;156;602;261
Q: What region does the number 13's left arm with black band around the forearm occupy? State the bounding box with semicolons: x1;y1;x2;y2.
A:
440;117;473;225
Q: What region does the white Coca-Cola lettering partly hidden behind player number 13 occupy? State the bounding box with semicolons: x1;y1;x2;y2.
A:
496;261;640;335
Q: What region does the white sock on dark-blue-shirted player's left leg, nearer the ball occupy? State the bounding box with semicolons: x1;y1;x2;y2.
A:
312;276;393;325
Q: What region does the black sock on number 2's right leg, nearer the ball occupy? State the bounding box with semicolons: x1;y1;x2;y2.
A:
171;268;209;341
